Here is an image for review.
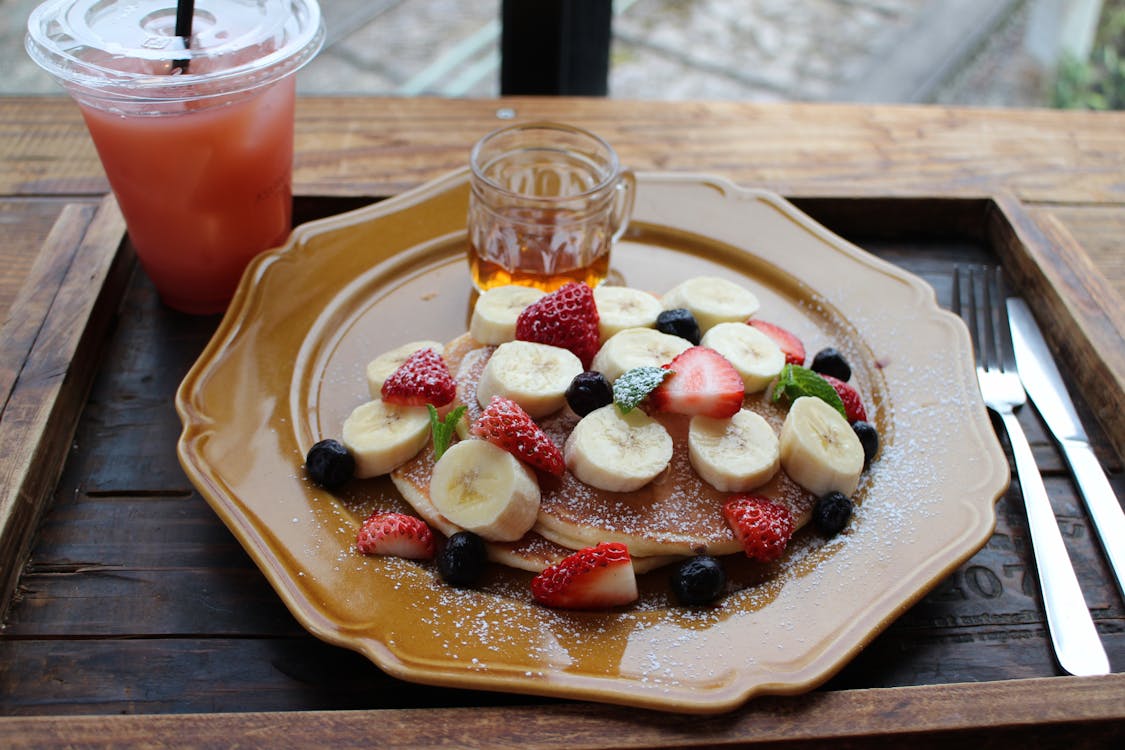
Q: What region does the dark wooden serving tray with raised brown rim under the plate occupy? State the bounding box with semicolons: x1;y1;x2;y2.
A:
0;196;1125;748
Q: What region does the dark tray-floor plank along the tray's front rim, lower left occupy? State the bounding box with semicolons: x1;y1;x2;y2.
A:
0;634;528;719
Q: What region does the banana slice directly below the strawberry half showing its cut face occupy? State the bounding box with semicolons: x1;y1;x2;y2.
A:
687;411;781;493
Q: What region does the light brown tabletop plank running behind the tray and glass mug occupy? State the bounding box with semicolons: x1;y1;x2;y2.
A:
0;97;1125;205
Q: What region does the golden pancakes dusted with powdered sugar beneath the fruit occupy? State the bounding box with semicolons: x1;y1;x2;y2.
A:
392;334;816;571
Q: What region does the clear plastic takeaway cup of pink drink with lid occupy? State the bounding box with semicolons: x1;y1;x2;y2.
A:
27;0;324;314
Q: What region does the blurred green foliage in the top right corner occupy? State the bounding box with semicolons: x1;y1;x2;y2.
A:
1052;0;1125;109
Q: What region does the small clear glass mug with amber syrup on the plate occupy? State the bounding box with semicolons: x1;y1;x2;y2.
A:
468;123;636;291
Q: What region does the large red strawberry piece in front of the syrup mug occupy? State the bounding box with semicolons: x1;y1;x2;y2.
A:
515;281;601;369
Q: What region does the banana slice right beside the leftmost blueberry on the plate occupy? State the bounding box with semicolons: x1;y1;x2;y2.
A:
341;400;430;478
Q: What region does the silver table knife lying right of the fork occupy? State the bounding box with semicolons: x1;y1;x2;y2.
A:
1007;297;1125;597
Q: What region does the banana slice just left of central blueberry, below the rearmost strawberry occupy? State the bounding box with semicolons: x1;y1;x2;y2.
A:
477;341;582;419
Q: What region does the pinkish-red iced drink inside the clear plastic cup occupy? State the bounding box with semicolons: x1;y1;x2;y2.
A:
82;76;295;314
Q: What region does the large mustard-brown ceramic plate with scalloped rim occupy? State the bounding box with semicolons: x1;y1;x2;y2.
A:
177;173;1008;712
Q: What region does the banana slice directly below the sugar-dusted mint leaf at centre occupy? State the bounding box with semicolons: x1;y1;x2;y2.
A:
563;404;672;493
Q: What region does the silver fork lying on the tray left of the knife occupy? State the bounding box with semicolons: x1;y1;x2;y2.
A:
953;266;1109;676
